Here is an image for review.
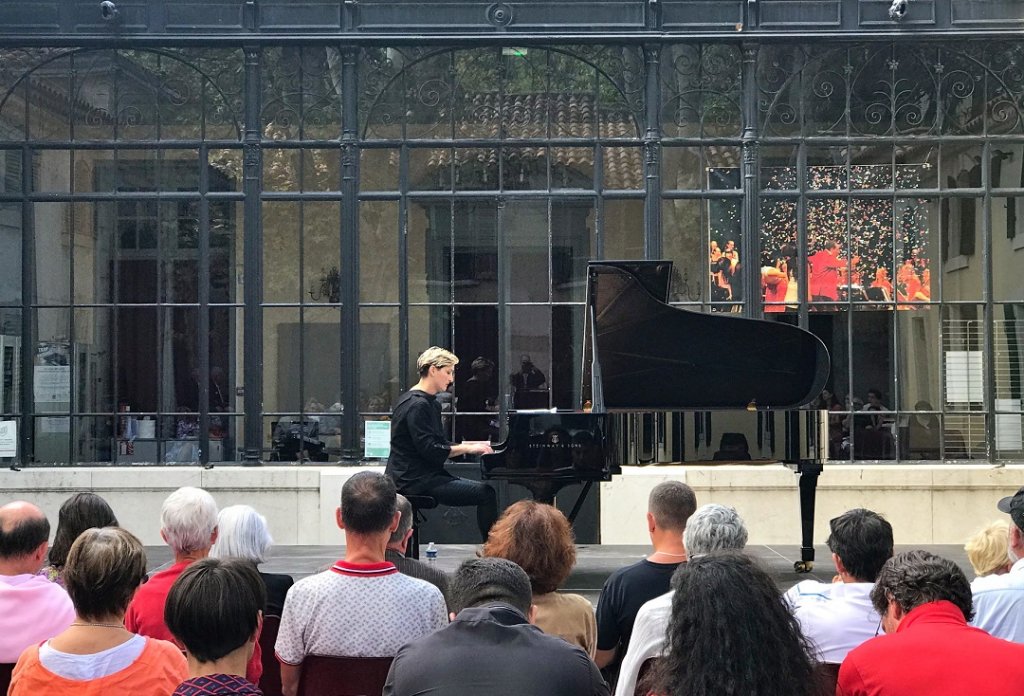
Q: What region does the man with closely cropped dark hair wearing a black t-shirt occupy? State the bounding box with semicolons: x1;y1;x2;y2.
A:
596;481;697;667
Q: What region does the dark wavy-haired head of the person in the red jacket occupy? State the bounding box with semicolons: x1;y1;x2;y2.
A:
871;550;974;621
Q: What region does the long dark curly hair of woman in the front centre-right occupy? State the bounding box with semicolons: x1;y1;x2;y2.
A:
653;552;819;696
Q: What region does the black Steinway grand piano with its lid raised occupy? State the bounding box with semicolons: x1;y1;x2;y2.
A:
481;261;829;571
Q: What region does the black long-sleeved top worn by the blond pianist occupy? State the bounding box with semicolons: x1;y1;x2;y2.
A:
385;389;455;494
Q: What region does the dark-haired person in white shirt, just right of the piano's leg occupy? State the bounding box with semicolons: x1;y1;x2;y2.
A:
785;508;893;664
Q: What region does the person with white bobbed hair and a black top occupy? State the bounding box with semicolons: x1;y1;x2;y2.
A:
210;505;295;616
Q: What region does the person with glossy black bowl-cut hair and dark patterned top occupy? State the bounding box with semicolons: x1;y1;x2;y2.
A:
164;558;267;696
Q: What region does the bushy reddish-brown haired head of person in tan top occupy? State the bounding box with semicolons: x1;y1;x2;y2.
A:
483;501;575;595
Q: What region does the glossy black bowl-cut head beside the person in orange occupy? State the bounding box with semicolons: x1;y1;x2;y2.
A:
164;558;266;662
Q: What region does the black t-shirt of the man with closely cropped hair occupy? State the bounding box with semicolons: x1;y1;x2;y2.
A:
597;559;680;661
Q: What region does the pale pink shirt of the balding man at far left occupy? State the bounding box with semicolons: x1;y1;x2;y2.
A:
0;575;75;662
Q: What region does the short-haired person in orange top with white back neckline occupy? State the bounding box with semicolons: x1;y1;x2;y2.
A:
8;527;188;696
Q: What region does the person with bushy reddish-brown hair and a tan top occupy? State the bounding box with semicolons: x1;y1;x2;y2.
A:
483;501;597;657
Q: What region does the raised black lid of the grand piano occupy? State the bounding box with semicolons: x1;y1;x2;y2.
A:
584;261;829;411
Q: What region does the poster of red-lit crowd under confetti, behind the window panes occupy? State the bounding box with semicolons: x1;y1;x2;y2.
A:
753;165;931;312
